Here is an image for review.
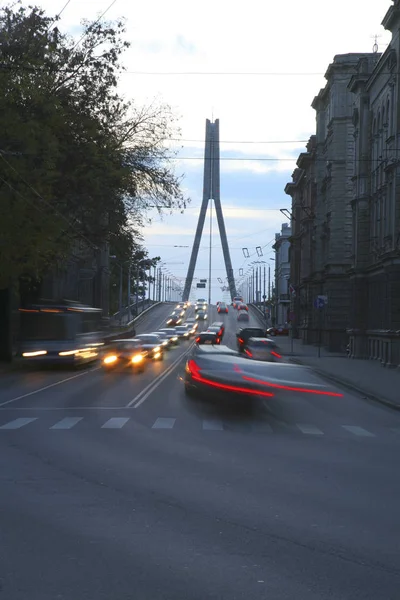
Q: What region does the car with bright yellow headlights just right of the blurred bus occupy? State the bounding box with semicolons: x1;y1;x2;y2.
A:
102;338;147;373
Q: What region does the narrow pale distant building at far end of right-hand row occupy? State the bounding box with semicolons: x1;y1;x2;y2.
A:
273;223;292;325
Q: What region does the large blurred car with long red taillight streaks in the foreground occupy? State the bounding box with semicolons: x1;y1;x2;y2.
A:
180;344;343;405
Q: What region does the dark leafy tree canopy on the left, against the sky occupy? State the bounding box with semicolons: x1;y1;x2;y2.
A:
0;3;187;288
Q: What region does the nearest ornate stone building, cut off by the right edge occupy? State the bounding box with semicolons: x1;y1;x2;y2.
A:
348;0;400;366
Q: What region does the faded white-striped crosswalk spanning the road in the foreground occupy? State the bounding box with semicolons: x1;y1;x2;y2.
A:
0;416;400;440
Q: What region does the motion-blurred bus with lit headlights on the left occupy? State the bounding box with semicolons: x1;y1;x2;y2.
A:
17;300;104;365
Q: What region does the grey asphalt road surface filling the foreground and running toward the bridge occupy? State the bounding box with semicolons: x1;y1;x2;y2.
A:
0;306;400;600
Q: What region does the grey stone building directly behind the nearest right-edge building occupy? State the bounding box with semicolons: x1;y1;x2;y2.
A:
285;53;376;351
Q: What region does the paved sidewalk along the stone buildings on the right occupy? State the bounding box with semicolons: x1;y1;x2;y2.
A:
274;336;400;410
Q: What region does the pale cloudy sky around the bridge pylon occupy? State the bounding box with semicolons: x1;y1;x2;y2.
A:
17;0;392;303
